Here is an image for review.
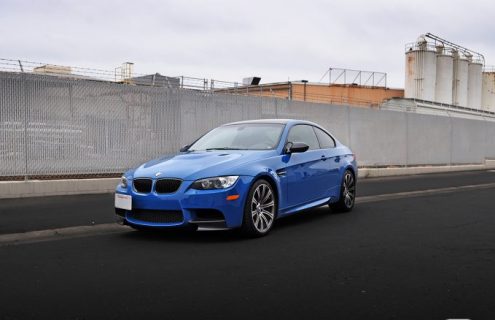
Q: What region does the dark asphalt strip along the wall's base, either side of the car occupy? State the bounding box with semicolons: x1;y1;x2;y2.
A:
0;171;495;235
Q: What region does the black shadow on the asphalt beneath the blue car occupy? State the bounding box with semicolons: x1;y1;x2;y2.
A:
119;206;350;243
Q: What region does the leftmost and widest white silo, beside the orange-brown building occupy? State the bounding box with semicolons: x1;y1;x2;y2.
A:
404;36;437;101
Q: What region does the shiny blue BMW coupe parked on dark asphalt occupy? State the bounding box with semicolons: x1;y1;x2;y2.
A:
115;119;357;237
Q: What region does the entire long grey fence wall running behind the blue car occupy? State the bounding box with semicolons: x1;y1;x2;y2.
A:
0;72;495;179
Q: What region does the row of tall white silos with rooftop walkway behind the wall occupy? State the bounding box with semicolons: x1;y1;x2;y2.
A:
404;33;495;112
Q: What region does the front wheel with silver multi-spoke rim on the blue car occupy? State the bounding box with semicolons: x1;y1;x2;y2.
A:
242;179;278;238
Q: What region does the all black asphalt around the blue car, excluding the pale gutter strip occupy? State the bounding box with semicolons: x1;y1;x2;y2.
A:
0;171;495;319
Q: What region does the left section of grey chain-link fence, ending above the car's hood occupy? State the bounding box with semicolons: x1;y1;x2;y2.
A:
0;73;180;177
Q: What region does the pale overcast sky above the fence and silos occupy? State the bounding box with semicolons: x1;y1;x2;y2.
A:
0;0;495;87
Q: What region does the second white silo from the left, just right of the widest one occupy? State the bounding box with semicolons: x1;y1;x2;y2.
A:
435;45;454;104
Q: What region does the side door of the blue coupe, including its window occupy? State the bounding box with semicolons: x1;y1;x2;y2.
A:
285;124;326;207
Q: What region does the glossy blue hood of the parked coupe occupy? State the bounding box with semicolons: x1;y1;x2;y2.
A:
133;150;275;180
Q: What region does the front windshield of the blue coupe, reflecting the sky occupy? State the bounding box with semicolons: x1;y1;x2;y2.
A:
188;123;284;151
